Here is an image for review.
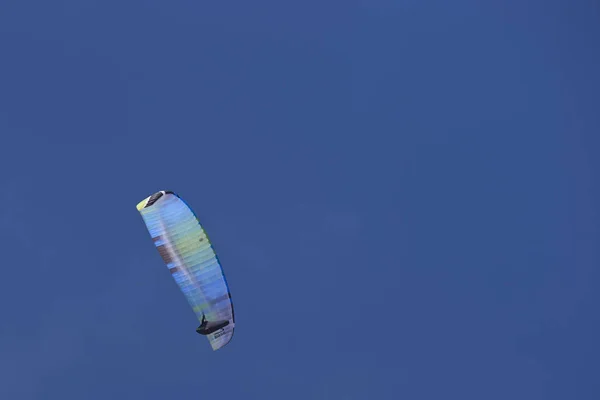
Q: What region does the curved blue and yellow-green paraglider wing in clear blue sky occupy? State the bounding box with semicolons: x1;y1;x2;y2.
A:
137;191;235;350
